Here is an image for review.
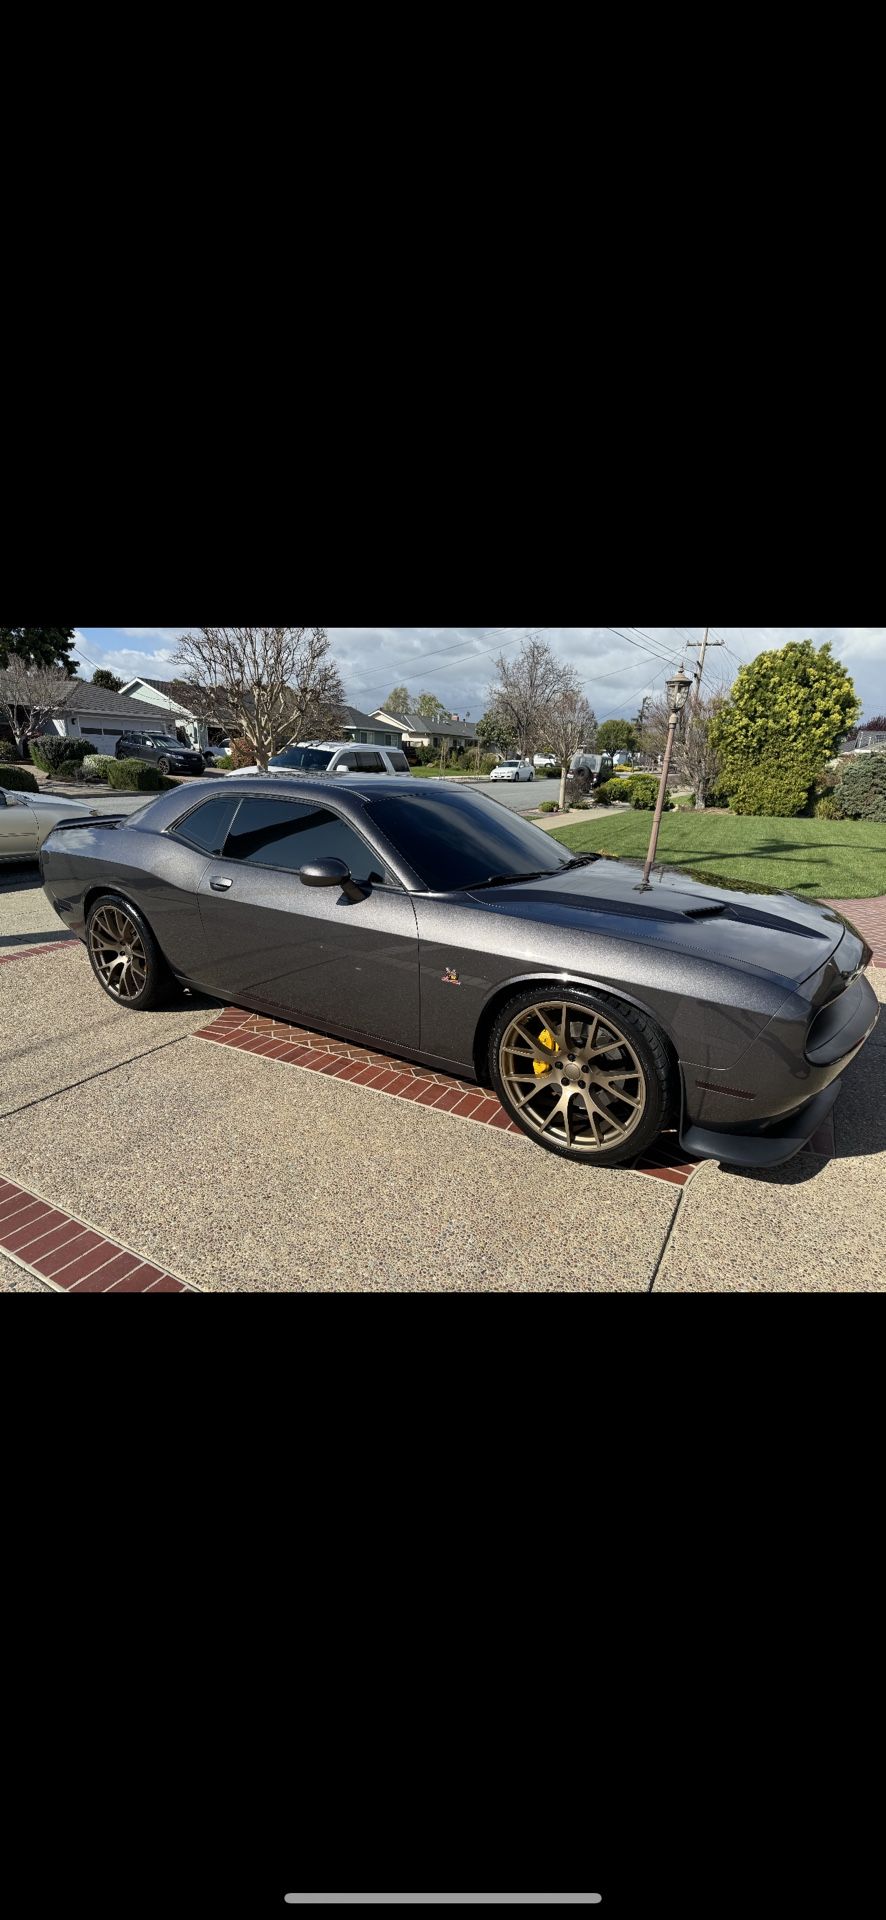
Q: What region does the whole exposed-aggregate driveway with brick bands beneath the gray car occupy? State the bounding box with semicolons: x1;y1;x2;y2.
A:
0;870;886;1292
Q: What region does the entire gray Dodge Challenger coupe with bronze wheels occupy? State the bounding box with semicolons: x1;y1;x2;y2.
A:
40;774;878;1167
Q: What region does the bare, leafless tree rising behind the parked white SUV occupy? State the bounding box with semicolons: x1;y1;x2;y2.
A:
175;626;344;768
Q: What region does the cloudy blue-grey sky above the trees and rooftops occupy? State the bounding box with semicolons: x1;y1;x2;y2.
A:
77;626;886;720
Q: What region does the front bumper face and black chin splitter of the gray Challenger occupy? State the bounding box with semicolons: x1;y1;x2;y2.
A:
680;973;880;1167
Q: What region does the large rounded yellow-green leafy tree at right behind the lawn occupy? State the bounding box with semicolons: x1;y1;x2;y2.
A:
711;639;861;816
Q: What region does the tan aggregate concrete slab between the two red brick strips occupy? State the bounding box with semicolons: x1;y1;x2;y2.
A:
2;1021;677;1292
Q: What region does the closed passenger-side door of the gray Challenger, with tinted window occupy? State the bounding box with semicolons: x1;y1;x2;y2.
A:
198;795;419;1048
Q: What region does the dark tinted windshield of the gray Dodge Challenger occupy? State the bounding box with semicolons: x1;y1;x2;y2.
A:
367;791;571;893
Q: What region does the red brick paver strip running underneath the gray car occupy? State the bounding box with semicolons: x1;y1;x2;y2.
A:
194;1006;700;1187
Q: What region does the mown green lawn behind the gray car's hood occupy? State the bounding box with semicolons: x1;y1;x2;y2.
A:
555;810;886;900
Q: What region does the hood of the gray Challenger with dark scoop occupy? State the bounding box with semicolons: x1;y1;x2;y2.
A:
463;858;846;985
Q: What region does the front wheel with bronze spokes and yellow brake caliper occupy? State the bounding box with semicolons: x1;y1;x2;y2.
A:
490;981;673;1167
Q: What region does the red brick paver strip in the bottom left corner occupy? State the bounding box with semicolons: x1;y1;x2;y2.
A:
0;1179;198;1294
